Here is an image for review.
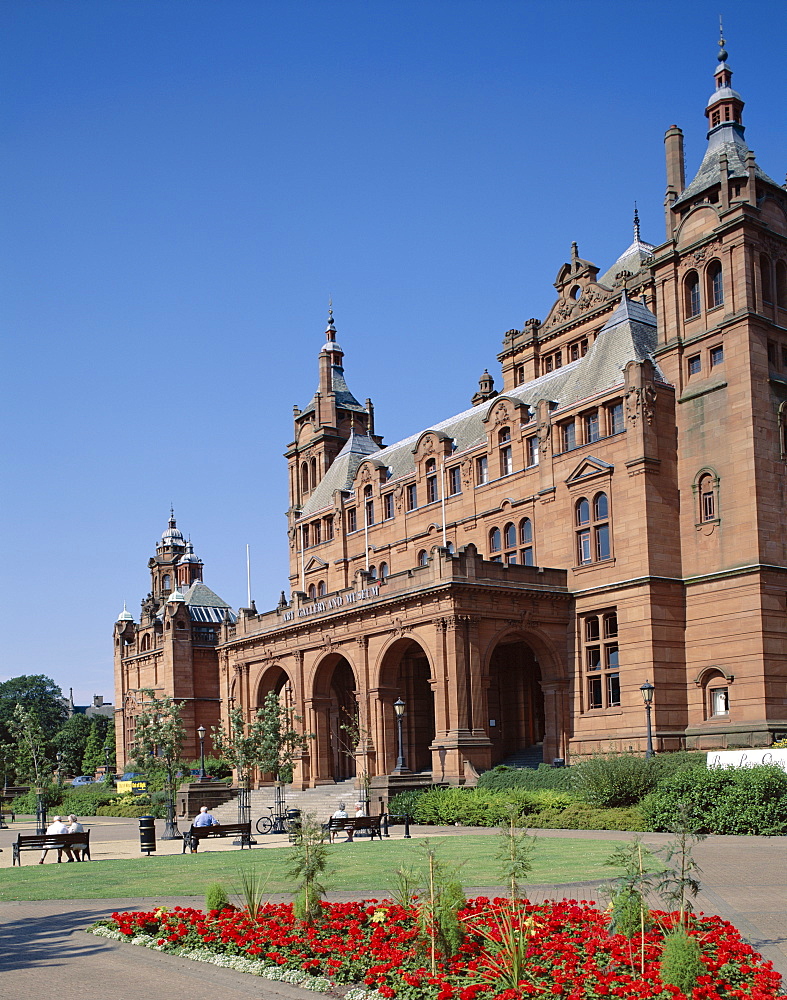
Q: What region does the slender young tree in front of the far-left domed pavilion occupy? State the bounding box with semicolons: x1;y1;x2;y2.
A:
132;688;186;840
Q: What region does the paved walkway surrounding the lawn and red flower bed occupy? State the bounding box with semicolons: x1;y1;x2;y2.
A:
0;817;787;1000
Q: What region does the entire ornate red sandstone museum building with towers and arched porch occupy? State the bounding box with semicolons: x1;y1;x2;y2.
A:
115;50;787;785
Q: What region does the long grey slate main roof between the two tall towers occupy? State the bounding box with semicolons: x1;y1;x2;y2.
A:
301;294;666;517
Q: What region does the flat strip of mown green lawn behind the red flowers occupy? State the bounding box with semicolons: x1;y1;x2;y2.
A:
0;836;617;901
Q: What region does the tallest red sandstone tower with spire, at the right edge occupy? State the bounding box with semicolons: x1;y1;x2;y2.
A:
652;38;787;745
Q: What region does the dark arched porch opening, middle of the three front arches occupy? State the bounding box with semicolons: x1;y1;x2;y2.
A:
314;654;358;781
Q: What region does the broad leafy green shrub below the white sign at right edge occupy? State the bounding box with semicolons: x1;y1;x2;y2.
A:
642;765;787;836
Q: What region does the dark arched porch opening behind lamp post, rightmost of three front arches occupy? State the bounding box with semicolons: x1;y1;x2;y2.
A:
379;639;435;774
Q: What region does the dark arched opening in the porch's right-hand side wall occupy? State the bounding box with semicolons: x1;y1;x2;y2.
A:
487;637;544;765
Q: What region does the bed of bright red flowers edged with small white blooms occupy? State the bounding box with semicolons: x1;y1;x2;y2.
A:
94;897;785;1000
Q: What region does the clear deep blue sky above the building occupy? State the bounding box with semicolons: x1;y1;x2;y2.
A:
0;0;787;703
